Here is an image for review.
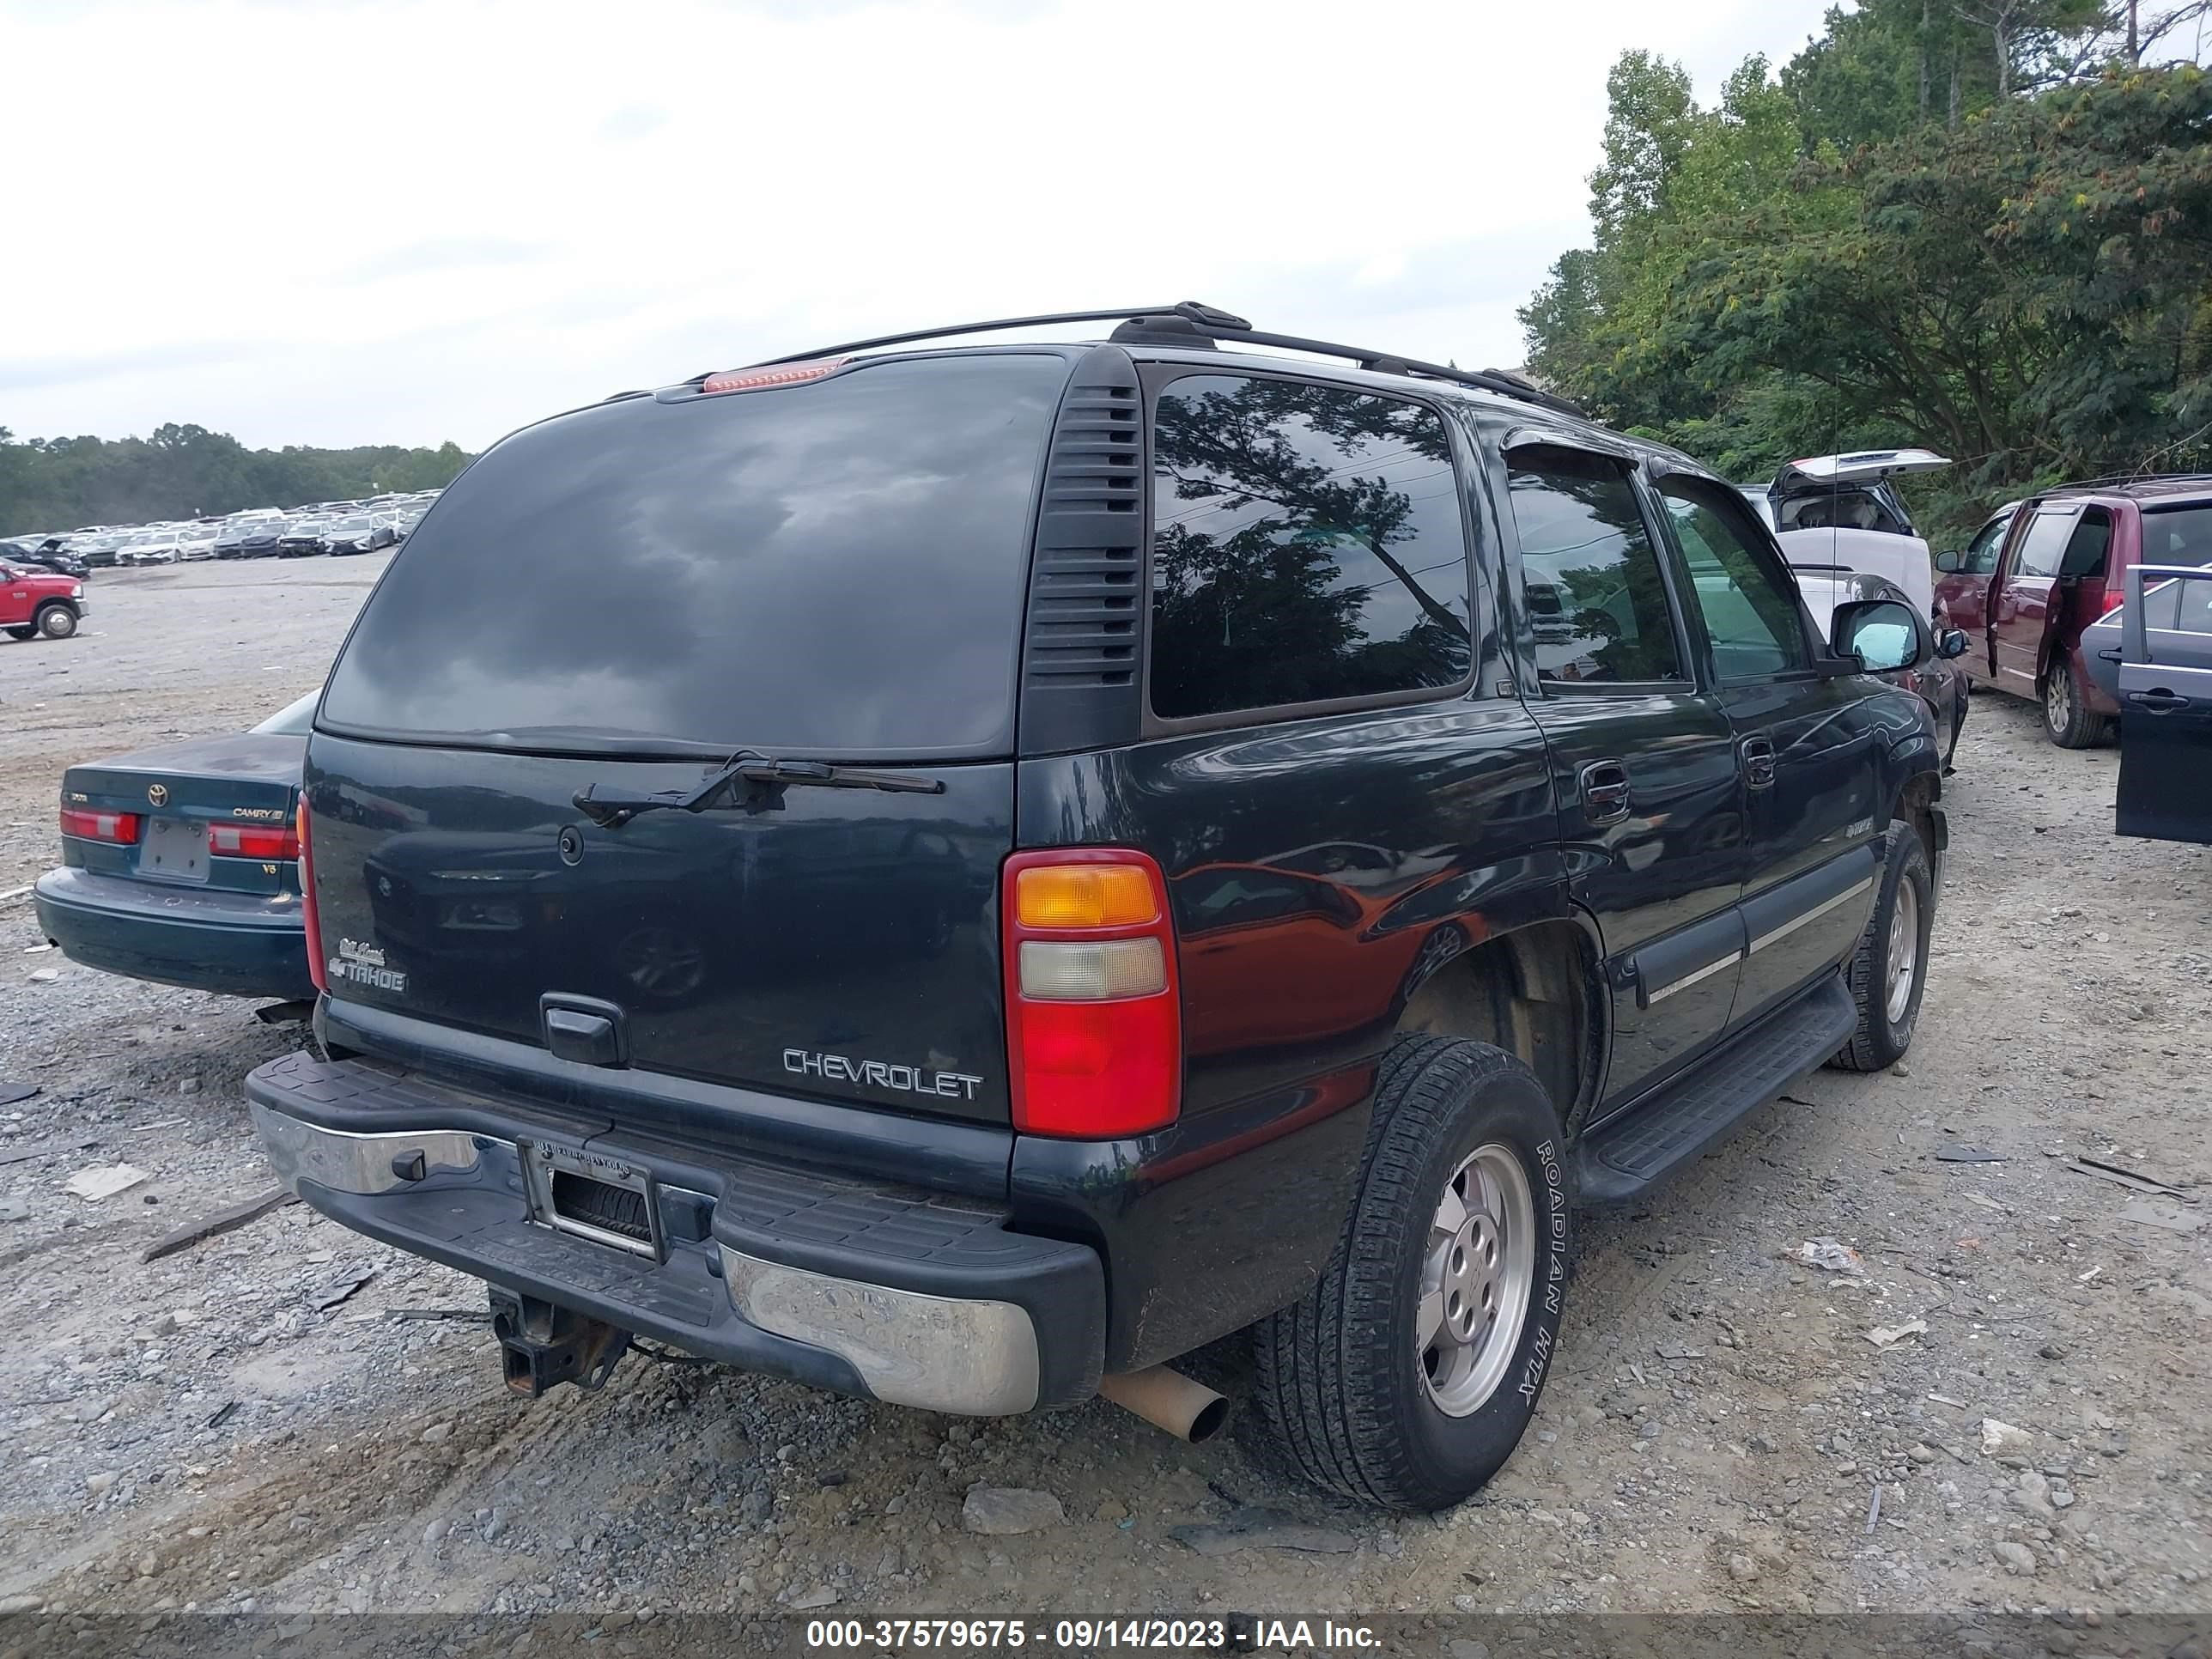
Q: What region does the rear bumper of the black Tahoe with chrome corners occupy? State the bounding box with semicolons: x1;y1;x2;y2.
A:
246;1055;1106;1416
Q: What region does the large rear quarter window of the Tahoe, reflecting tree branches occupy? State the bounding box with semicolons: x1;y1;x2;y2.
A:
1151;374;1471;719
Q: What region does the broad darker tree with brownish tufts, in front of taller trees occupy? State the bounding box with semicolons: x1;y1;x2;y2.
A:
1663;66;2212;484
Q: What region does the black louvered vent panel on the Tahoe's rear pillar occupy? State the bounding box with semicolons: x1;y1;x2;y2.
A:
1022;347;1144;752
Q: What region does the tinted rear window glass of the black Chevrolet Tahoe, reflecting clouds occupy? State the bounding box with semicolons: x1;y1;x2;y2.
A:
321;354;1068;759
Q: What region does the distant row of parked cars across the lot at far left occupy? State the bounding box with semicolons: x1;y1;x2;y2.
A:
0;489;441;580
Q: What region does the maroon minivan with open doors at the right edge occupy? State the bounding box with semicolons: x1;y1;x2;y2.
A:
1936;477;2212;750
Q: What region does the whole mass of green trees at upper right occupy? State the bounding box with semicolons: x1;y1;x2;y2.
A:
1520;0;2212;546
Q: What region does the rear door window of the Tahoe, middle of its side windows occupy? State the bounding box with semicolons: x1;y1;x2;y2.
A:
1506;447;1683;686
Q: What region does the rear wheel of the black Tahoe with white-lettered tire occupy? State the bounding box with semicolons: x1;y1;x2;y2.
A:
1252;1037;1573;1510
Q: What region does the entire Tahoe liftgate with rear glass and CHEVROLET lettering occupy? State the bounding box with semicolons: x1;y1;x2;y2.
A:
307;352;1068;1124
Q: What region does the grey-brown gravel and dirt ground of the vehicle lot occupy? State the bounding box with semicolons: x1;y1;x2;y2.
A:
0;557;2212;1646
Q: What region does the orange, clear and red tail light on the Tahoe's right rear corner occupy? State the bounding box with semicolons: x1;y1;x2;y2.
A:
1000;848;1183;1139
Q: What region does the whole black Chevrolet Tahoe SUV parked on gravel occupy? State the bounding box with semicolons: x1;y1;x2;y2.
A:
248;303;1944;1509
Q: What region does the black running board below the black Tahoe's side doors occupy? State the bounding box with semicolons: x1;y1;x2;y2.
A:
1575;973;1858;1203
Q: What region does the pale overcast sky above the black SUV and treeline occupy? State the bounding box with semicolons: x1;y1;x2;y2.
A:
0;0;1827;449
